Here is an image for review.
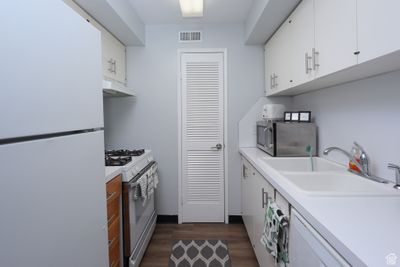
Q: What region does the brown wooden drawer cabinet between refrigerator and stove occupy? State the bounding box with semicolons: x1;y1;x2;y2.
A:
106;175;122;267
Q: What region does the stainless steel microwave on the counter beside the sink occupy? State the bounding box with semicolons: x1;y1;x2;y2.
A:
257;121;318;157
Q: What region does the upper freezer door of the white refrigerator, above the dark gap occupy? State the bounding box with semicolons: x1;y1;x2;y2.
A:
0;0;103;140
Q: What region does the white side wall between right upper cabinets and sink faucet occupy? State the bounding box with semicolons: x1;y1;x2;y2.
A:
293;72;400;184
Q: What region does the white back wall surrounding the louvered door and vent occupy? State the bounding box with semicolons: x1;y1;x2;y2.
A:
105;24;282;215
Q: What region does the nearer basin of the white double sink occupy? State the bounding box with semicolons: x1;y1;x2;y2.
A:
282;172;400;196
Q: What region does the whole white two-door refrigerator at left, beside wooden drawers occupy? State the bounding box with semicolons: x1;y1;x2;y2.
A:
0;0;108;267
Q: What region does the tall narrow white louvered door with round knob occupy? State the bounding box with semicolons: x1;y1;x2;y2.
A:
181;53;225;222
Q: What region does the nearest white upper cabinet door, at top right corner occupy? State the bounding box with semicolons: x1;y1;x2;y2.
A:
357;0;400;63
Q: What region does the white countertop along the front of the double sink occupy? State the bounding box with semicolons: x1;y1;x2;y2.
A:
239;148;400;266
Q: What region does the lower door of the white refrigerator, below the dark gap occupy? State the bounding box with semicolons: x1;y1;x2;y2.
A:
0;131;108;267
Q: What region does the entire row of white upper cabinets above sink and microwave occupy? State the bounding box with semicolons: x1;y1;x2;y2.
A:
265;0;400;96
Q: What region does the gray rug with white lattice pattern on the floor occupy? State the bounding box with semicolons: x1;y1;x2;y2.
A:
168;240;231;267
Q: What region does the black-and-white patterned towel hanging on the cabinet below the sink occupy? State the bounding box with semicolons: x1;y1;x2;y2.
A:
260;199;289;265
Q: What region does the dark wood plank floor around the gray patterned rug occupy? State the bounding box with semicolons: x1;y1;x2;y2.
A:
140;224;259;267
